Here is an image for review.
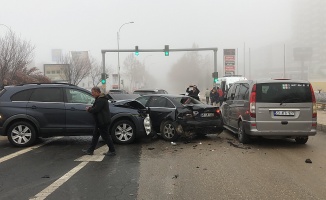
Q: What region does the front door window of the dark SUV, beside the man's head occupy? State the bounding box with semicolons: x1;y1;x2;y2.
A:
66;88;94;104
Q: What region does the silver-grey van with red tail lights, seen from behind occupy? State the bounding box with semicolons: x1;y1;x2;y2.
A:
221;79;317;144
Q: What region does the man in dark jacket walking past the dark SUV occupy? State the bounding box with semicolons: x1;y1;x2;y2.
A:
83;87;115;156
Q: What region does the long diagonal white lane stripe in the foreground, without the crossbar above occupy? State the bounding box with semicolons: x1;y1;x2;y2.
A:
30;162;88;200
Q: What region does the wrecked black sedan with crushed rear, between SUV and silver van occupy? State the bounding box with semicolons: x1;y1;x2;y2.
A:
136;94;223;141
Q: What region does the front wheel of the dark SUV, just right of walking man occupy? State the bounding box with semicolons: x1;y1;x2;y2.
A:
111;120;136;144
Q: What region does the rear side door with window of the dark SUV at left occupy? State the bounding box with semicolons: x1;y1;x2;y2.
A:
26;87;66;136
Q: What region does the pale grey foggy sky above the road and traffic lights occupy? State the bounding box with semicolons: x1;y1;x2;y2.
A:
0;0;326;92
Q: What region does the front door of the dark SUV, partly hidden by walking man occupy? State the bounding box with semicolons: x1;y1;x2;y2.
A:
65;88;95;135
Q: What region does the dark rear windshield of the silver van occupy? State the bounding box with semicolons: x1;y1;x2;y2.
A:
256;83;312;103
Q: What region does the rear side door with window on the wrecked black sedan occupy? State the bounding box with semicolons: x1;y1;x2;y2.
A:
146;96;176;131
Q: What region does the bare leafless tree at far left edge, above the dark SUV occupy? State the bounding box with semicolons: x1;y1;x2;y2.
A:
0;32;35;85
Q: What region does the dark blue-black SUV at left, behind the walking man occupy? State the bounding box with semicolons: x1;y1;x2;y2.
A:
0;83;150;147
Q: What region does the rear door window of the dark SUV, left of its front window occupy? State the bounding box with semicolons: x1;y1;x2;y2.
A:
30;88;63;102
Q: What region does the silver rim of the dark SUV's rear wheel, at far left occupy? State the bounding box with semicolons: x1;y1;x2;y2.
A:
11;125;32;144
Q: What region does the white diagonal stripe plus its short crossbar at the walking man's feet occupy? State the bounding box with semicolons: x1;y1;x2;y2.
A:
29;145;108;200
